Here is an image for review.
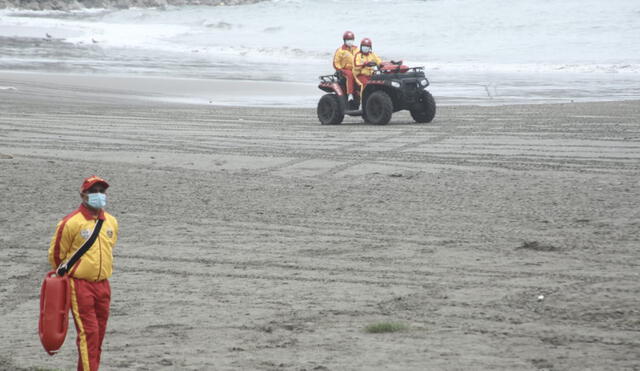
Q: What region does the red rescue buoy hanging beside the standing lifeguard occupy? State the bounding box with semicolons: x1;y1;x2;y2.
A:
38;271;71;355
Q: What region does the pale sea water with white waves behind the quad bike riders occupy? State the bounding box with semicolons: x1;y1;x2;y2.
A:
0;0;640;106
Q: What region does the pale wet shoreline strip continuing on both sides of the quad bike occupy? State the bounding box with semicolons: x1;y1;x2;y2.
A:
5;70;639;109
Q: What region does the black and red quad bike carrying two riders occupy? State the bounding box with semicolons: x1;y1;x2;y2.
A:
318;61;436;125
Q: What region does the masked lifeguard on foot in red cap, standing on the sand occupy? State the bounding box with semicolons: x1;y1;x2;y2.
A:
49;176;118;371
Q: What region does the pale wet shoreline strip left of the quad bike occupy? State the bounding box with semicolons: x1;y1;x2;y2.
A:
0;70;320;108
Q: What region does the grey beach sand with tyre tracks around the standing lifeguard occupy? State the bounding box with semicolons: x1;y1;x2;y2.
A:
0;73;640;370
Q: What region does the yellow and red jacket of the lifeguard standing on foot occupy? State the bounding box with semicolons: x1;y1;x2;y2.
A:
49;205;118;282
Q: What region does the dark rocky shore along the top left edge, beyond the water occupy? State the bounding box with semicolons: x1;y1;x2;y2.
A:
0;0;263;10
